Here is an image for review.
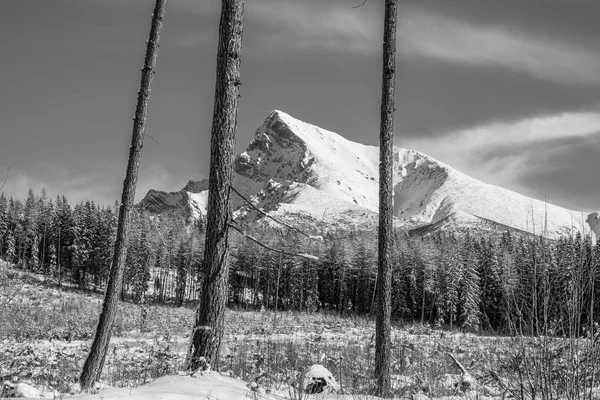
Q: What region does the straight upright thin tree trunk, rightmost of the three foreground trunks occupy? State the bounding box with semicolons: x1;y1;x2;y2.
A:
375;0;398;397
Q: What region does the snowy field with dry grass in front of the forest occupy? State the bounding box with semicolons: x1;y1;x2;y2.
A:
0;270;598;399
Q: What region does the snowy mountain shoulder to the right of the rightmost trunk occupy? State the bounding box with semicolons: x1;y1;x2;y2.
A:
394;149;590;236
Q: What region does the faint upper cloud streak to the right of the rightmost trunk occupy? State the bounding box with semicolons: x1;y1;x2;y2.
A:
398;10;600;84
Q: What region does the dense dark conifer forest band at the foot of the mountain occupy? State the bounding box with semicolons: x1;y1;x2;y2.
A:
0;190;600;335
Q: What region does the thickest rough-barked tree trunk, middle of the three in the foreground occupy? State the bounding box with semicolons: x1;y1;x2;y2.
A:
189;0;244;369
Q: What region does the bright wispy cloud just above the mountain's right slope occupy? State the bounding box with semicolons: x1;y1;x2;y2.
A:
402;112;600;190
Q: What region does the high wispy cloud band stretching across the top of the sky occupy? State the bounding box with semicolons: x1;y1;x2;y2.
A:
98;0;600;85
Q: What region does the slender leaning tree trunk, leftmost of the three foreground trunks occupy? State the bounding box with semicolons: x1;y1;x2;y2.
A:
79;0;167;389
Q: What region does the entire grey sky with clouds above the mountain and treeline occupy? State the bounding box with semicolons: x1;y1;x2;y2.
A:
0;0;600;211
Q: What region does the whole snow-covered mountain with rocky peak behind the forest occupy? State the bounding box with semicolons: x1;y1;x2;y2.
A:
141;111;599;236
